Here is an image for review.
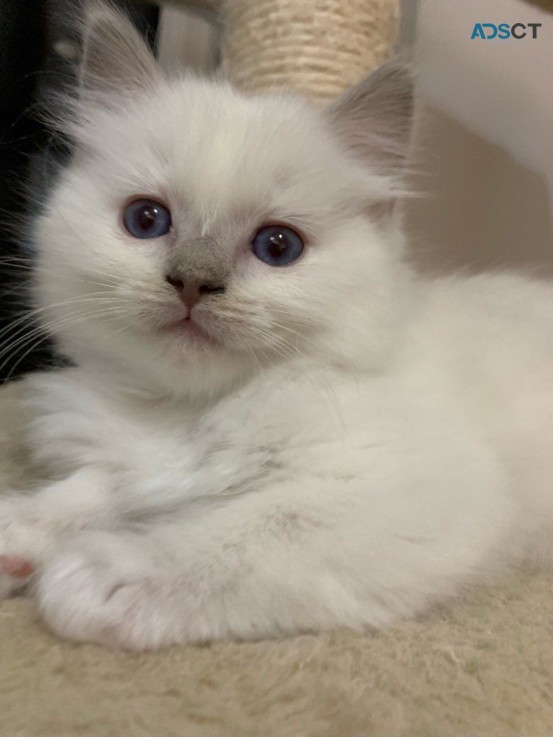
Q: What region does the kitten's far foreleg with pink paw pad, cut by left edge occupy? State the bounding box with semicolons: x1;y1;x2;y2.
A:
0;467;111;599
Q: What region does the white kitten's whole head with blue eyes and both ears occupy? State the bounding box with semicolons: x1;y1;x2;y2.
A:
34;5;411;394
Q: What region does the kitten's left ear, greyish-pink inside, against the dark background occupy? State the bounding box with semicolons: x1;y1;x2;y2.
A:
79;1;160;100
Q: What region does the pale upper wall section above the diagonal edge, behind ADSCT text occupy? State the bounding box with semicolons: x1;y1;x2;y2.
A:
418;0;553;198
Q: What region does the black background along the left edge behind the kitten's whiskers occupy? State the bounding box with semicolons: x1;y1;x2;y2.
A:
0;0;158;383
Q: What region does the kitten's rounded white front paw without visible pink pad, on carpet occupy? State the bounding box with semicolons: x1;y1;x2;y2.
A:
35;532;182;650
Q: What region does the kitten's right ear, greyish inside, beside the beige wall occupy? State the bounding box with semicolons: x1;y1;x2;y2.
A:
327;58;413;176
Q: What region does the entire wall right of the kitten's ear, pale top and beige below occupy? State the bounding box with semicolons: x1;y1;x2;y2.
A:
406;0;553;270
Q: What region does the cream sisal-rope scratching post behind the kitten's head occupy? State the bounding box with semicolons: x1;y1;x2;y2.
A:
220;0;399;102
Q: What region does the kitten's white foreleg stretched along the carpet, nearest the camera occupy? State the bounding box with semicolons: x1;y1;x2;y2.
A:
36;460;511;649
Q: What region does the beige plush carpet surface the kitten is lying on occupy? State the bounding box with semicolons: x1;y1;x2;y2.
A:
0;380;553;737
